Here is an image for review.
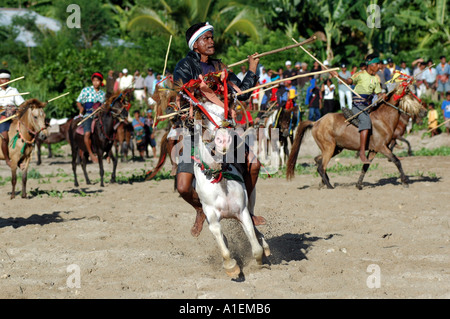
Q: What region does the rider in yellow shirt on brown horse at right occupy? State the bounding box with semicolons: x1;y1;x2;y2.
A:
330;54;386;164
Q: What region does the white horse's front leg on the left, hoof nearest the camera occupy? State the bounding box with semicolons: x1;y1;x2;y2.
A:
203;206;241;278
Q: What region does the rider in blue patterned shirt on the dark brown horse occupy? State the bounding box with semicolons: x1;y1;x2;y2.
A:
76;72;106;163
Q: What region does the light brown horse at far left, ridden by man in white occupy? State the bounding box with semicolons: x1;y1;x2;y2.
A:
0;99;47;199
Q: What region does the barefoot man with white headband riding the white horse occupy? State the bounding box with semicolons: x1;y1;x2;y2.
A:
169;22;264;237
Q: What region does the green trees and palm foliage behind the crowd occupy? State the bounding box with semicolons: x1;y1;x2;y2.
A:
0;0;450;118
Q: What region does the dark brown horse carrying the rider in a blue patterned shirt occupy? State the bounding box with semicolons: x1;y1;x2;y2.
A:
69;90;132;187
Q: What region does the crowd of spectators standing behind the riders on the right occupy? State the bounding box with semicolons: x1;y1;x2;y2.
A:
241;56;450;131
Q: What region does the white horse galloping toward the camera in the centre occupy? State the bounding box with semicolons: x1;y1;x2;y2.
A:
194;102;270;278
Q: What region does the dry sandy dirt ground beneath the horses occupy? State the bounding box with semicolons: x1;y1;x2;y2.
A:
0;130;450;299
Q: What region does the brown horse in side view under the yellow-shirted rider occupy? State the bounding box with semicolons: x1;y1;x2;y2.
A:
286;86;422;189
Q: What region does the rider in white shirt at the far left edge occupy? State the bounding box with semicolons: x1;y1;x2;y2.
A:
0;69;25;166
